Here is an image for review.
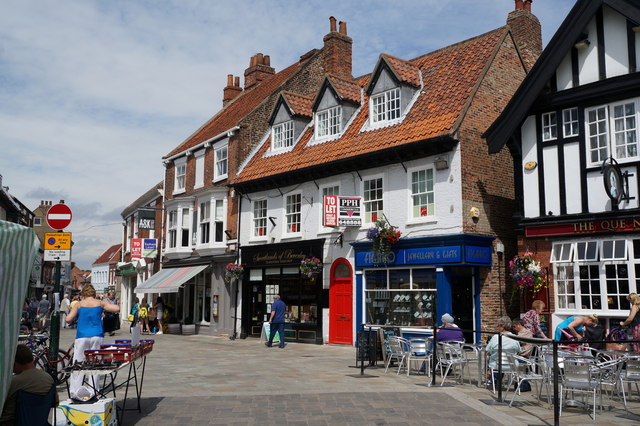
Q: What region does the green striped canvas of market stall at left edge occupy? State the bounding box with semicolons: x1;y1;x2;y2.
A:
0;220;40;404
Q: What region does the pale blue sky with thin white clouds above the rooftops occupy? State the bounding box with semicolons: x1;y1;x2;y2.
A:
0;0;575;269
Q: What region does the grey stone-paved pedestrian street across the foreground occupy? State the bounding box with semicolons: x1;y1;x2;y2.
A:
55;329;640;426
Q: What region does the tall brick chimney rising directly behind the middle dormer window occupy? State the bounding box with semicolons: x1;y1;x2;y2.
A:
322;16;353;79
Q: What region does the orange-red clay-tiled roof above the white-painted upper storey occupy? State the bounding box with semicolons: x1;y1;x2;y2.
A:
235;27;506;183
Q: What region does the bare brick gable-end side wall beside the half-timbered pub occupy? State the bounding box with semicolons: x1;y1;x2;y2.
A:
460;33;525;329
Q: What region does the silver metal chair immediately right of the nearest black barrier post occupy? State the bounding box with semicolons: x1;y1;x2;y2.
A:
560;357;602;421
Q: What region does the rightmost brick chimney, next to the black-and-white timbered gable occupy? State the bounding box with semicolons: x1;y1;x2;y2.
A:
507;0;542;71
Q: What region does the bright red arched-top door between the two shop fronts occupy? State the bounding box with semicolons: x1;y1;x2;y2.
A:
329;258;353;345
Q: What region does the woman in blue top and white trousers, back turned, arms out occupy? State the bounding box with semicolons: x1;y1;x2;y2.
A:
65;284;120;398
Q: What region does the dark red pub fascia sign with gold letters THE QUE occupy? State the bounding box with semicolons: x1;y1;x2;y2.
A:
525;218;640;237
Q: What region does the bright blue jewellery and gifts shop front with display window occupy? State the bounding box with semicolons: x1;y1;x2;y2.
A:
351;234;494;341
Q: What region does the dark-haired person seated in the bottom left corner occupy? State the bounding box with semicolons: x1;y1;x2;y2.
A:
0;344;58;425
